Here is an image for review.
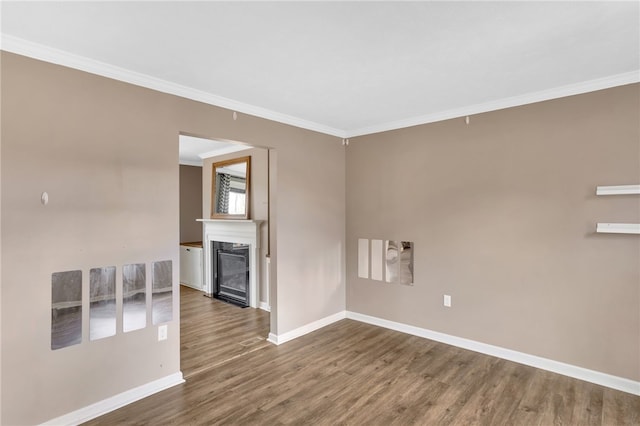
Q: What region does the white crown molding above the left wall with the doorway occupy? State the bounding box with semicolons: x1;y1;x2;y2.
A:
0;34;345;138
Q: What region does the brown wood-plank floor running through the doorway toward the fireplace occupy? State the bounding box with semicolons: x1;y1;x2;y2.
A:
88;289;640;425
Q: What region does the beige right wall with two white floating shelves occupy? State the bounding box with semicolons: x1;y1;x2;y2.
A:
347;84;640;380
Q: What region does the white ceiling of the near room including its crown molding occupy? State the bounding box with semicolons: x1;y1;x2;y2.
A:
1;1;640;137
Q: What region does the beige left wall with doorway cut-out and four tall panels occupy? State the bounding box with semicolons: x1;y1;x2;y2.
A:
0;52;345;424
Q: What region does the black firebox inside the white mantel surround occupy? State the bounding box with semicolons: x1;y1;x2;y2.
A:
211;241;251;307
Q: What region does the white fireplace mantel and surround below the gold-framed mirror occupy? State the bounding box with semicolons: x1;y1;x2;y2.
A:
196;219;264;308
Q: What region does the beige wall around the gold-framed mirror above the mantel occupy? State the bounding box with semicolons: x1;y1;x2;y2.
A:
200;148;275;306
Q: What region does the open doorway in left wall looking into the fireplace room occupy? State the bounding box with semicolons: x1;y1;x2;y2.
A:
179;134;272;379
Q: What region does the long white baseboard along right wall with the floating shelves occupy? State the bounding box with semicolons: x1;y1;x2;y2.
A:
347;311;640;395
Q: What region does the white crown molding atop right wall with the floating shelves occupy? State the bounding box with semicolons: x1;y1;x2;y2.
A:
344;70;640;138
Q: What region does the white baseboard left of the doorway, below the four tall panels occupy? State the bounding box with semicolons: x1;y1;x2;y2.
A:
42;372;184;426
